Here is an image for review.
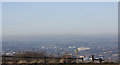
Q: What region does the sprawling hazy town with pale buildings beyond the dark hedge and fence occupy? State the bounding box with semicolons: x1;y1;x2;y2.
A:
2;40;118;63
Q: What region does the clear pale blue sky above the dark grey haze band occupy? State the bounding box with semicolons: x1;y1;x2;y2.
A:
2;2;118;36
